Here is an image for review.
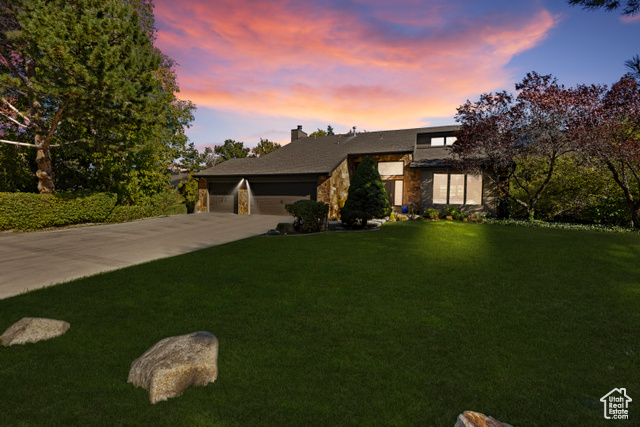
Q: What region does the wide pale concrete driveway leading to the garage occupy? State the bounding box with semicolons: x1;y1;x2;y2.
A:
0;213;293;299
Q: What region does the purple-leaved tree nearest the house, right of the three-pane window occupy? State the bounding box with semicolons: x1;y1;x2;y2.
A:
451;72;588;219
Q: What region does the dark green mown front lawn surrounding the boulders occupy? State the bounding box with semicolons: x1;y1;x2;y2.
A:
0;222;640;426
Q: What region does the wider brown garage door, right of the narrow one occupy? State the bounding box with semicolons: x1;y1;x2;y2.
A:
249;182;316;215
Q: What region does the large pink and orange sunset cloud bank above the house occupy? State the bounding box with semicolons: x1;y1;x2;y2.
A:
155;0;558;129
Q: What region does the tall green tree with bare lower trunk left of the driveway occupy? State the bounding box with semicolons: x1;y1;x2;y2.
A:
0;0;168;194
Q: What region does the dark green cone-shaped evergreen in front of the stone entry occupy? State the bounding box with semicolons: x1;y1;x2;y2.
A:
340;157;391;227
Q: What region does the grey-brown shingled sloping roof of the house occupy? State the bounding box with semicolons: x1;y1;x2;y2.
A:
196;126;459;176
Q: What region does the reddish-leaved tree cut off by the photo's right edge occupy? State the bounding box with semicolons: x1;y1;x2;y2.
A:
577;74;640;228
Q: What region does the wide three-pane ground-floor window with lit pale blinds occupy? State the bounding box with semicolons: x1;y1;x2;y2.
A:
433;173;482;205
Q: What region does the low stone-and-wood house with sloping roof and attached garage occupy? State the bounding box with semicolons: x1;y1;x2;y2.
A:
195;126;497;219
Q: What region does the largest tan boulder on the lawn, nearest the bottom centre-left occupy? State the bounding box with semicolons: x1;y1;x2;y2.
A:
127;331;218;403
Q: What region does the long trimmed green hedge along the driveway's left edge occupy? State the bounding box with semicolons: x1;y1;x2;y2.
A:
0;192;117;230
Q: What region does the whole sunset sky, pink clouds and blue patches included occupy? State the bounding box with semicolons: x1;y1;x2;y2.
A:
155;0;640;150
